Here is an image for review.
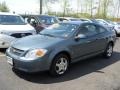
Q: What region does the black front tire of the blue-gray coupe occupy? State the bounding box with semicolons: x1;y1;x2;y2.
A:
49;54;69;76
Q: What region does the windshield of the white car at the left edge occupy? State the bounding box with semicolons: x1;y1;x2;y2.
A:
0;15;25;25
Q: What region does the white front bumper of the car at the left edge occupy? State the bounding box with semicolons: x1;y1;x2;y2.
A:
0;34;16;48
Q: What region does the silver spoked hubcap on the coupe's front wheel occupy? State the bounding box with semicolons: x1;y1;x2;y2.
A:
56;58;68;74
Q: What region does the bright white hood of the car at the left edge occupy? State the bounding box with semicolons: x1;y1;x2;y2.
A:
0;24;34;32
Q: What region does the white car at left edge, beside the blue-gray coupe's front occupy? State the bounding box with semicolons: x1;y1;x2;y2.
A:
0;12;36;48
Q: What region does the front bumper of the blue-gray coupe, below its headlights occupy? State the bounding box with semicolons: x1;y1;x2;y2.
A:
6;51;49;73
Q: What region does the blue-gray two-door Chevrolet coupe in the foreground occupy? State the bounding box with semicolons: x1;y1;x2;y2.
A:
6;21;116;76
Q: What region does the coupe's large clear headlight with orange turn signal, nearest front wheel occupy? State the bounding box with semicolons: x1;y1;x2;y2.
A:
24;49;47;60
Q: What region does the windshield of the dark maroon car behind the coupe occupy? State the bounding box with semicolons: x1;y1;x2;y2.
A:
39;16;58;25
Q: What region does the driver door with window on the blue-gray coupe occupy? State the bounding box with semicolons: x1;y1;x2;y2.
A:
73;24;99;59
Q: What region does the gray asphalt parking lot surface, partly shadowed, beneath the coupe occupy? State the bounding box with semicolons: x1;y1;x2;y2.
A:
0;39;120;90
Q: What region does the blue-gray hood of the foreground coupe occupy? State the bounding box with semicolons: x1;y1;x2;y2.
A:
11;35;63;50
